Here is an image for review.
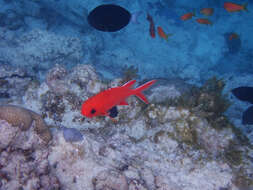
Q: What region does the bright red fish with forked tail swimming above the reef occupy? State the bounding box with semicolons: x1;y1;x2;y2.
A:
81;80;156;118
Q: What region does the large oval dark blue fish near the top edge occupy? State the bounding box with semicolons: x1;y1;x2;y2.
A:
88;4;131;32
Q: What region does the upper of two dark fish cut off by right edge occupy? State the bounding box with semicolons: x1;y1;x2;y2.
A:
232;86;253;104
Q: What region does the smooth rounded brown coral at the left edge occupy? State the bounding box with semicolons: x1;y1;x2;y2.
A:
0;105;52;144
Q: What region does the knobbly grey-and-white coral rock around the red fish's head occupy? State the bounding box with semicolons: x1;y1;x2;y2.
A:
23;65;106;129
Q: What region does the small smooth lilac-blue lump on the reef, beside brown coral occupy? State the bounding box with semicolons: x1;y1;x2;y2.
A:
61;127;83;142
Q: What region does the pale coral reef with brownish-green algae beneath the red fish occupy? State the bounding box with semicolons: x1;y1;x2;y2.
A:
2;65;253;190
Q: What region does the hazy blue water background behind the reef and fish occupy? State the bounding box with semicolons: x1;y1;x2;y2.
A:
0;0;253;137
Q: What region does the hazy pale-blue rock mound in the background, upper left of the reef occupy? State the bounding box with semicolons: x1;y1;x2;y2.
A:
0;30;83;78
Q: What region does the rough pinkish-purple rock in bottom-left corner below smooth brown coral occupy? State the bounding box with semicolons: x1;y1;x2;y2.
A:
0;119;61;190
